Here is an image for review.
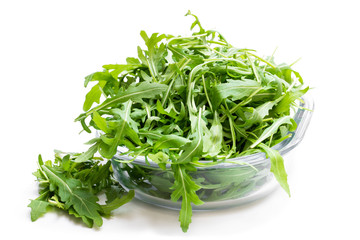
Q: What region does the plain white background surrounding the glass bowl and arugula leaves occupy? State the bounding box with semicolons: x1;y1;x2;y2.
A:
0;0;360;240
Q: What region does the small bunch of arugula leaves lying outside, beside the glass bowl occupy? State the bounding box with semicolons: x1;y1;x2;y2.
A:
28;151;134;227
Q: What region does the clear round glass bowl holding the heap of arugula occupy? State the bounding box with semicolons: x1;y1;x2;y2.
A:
112;94;314;210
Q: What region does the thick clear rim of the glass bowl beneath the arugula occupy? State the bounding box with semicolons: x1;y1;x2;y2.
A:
113;93;314;169
